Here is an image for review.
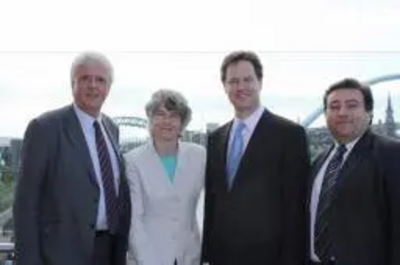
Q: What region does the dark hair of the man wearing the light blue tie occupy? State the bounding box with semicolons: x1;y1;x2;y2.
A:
221;51;263;82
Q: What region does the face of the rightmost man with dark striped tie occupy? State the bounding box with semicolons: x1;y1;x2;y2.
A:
325;88;372;143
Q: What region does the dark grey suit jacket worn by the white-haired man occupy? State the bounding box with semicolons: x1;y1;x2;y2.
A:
14;106;130;265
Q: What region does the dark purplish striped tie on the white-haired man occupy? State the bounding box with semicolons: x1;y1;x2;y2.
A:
93;121;118;234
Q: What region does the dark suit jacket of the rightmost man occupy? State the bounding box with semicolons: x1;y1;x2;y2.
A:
308;131;400;265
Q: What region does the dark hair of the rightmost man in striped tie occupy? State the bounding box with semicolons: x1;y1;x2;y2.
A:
324;78;374;113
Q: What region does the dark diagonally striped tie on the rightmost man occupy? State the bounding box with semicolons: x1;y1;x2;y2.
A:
314;144;346;262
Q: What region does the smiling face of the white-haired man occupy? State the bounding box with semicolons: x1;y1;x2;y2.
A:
72;62;111;117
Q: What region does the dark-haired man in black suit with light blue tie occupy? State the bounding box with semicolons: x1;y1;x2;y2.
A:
202;51;309;265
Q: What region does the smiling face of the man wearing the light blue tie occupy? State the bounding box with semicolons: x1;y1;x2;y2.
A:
223;60;262;118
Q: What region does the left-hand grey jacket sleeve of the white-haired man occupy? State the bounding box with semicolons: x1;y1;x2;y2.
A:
13;120;55;265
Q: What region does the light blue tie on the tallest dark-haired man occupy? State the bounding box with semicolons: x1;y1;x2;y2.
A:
226;122;246;187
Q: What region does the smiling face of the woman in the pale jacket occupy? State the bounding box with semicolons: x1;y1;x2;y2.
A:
150;105;182;142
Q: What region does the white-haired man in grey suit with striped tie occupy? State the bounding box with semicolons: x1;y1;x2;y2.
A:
14;53;130;265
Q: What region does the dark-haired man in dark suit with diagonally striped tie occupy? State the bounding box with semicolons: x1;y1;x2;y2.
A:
308;79;400;265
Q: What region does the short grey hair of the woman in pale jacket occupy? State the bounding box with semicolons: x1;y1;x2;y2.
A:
146;89;192;129
